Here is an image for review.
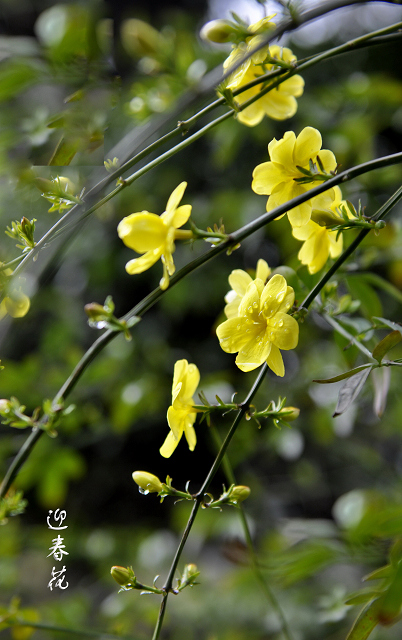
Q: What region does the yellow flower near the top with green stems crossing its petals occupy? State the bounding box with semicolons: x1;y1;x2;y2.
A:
227;44;304;127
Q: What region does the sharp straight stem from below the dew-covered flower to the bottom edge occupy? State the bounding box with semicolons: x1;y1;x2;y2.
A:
152;363;268;640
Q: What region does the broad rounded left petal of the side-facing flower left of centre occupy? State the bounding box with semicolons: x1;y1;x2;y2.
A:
117;211;168;253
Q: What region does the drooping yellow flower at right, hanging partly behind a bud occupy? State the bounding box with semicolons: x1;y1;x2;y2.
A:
292;187;354;274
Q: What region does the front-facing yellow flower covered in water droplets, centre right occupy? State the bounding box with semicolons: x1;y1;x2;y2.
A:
216;274;299;377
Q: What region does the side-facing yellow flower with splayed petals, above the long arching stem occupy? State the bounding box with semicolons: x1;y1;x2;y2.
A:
117;182;192;289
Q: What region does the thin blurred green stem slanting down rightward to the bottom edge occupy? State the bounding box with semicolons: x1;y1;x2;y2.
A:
210;425;293;640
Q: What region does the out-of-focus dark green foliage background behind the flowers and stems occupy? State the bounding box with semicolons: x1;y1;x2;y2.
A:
0;0;402;640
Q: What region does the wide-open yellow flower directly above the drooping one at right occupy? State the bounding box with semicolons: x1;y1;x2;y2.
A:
251;127;336;227
